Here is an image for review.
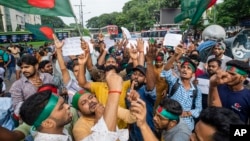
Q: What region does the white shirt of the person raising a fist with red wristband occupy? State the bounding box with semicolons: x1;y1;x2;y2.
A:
81;117;129;141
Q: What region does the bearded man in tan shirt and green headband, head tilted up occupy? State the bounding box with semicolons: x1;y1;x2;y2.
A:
72;88;136;141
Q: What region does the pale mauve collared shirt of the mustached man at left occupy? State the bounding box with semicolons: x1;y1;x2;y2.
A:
9;73;53;110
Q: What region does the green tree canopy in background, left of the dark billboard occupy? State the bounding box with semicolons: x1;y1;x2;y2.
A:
87;0;180;31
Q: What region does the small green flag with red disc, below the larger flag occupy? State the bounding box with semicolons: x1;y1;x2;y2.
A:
25;23;54;41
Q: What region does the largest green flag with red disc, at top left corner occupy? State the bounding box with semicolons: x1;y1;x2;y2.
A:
0;0;75;17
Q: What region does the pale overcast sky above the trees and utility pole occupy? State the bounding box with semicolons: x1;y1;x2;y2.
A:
61;0;129;25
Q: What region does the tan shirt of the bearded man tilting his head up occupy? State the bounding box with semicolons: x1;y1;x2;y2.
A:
73;107;136;141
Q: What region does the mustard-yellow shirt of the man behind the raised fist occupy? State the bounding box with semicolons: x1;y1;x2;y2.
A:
90;80;130;129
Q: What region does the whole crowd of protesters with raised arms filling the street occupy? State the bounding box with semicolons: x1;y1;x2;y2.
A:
0;33;250;141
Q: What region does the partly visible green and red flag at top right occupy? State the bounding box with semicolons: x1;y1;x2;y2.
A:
190;0;217;25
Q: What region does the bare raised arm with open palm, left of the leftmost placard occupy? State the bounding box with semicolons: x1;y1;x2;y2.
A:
53;34;71;84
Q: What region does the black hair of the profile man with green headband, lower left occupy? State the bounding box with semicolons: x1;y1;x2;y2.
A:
20;91;51;125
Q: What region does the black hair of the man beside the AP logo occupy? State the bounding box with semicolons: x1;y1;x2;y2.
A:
199;106;244;141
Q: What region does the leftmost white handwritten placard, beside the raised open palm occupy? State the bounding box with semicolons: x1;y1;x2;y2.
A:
62;36;93;56
